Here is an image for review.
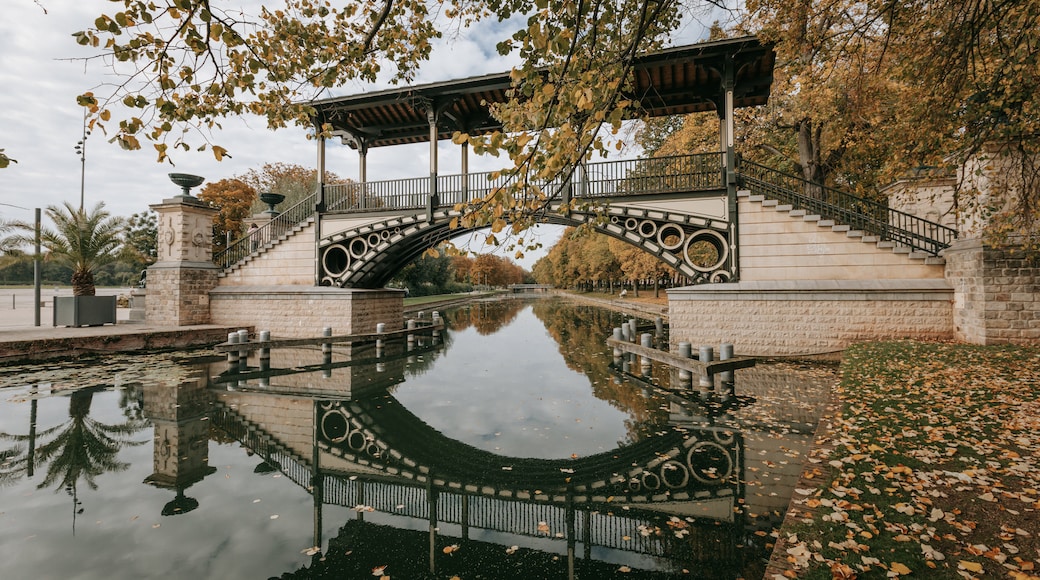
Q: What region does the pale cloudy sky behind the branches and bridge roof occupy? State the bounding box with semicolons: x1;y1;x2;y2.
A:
0;0;719;268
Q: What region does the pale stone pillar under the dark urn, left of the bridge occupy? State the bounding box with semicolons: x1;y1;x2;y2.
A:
146;197;219;326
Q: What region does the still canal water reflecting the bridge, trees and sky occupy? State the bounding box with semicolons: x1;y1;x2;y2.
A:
0;297;836;579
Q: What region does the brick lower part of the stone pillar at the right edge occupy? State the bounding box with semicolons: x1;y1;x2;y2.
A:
943;239;1040;344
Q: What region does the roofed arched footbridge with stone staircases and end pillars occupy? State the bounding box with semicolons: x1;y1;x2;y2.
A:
147;38;1036;355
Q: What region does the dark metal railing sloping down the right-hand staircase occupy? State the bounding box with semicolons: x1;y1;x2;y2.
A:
737;159;957;256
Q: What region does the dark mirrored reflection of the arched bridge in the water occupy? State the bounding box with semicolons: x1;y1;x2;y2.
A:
136;298;827;578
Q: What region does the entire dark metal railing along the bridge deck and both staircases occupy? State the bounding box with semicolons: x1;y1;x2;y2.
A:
213;153;957;268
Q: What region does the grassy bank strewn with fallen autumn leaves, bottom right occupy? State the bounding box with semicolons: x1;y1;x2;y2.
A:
769;342;1040;580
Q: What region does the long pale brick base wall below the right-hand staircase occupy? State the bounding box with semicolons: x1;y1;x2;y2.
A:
668;280;954;355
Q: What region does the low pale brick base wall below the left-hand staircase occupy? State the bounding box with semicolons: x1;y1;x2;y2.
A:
209;286;405;338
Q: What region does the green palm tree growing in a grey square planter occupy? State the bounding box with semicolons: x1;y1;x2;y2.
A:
16;202;123;296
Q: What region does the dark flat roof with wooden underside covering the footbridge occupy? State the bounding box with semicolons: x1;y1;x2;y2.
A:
311;36;776;148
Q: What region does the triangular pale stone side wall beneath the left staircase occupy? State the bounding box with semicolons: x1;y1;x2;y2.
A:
219;223;316;286
